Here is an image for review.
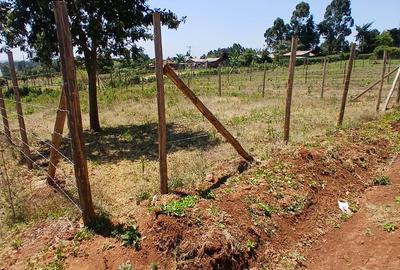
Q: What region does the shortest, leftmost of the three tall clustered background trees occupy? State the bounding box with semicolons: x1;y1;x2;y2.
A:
264;18;290;54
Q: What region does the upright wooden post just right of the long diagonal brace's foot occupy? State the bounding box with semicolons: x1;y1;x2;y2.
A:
283;36;297;143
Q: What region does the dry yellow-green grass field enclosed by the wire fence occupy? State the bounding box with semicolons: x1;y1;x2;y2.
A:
0;57;400;221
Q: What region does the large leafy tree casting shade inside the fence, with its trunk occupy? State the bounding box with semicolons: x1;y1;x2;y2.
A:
2;0;185;131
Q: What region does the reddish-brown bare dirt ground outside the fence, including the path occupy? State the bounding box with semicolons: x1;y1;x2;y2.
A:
0;115;400;270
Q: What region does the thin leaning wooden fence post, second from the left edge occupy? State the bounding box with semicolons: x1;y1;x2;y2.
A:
7;51;33;170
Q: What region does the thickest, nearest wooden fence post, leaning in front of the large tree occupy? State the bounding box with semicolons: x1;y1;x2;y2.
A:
53;1;95;226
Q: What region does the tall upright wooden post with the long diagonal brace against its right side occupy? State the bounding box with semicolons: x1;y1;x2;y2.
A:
153;13;168;194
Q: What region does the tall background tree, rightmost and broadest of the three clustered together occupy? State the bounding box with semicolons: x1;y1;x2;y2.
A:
318;0;354;54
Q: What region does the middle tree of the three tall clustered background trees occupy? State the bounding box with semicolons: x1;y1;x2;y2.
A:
290;2;319;50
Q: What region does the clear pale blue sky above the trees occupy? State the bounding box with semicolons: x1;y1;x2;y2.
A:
0;0;400;61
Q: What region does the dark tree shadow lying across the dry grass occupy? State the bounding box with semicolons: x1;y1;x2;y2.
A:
34;123;220;163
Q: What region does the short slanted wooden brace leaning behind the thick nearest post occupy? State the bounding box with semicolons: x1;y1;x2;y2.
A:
47;87;67;185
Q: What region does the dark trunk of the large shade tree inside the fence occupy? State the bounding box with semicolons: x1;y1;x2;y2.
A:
85;51;101;131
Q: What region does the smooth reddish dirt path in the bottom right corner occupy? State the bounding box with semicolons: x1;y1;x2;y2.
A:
306;157;400;270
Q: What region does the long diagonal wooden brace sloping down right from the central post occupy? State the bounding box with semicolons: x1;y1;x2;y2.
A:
164;64;254;162
